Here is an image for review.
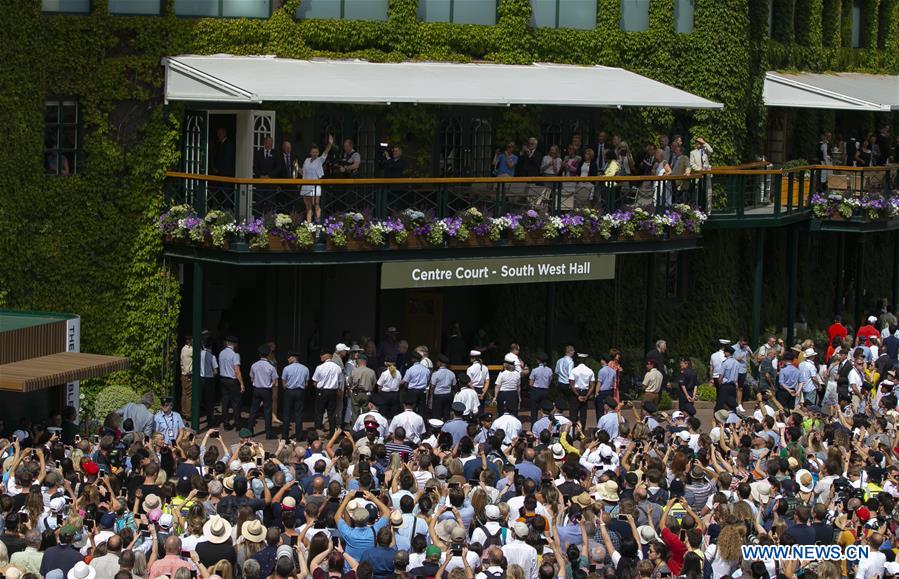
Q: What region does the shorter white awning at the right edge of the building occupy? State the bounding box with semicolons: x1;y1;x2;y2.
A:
764;72;899;111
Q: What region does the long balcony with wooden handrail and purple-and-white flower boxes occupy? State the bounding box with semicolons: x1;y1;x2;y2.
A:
160;163;899;264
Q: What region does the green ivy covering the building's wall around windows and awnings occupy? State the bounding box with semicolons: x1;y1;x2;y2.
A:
0;0;899;398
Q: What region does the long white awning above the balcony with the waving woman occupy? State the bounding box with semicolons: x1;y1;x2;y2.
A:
162;54;723;109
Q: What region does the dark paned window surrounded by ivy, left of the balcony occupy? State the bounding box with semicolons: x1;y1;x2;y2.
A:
44;99;81;176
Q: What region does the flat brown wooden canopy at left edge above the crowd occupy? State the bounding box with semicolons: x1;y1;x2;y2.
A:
0;352;128;392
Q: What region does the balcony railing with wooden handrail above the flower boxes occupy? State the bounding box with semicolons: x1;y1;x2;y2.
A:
165;162;899;222
